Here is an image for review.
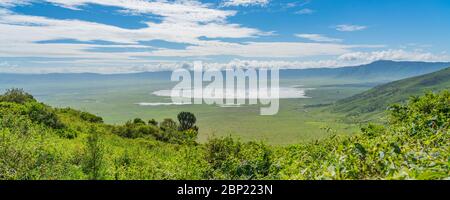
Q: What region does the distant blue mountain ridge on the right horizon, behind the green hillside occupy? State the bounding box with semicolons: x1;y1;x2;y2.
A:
280;60;450;82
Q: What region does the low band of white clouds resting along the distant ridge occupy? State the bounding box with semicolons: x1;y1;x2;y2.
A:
0;50;450;74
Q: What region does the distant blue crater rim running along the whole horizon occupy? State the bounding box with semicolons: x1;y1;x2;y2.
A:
0;60;450;84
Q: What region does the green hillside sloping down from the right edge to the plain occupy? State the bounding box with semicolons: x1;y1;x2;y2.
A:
333;67;450;115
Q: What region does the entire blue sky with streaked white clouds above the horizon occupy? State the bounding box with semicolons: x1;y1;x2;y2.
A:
0;0;450;73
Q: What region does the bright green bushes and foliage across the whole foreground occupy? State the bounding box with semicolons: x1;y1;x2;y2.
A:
0;90;450;180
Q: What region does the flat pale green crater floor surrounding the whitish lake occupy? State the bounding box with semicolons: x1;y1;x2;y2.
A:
3;79;373;145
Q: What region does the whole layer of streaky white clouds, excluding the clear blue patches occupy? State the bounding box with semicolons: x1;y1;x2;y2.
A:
0;0;449;73
